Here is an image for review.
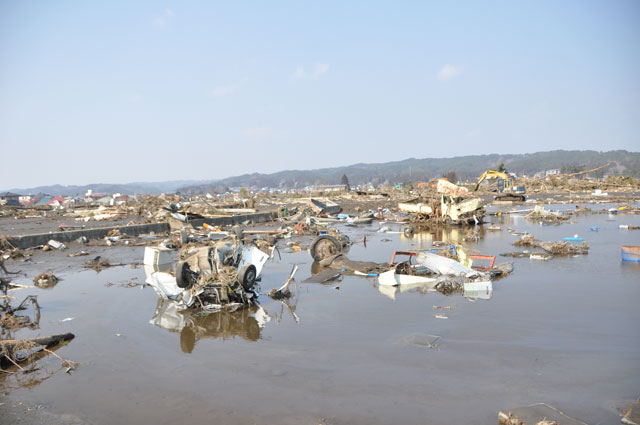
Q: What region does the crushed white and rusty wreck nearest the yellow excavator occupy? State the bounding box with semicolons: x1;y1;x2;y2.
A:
398;179;485;225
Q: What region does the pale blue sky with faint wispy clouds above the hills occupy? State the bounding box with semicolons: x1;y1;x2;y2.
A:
0;0;640;189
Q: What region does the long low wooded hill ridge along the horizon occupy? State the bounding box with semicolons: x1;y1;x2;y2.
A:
6;150;640;196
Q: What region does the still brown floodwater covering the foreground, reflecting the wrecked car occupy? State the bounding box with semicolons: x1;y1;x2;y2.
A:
0;204;640;425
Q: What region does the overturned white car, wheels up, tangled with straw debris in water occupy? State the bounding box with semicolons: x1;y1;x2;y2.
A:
145;236;270;310
